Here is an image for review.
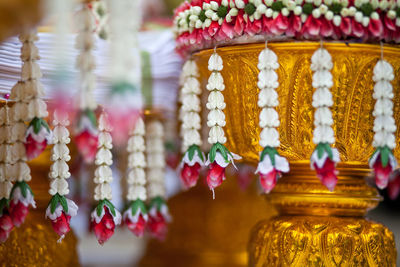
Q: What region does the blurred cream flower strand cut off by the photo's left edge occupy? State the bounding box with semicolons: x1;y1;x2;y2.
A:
0;106;15;199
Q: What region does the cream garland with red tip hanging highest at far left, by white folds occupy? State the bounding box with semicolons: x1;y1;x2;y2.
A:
14;31;51;160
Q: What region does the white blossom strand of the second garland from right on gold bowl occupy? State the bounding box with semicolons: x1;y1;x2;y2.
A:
311;48;335;144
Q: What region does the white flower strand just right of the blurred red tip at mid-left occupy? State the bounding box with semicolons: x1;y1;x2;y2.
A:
93;113;113;200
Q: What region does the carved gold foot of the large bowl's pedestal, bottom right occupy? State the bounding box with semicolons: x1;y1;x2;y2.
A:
249;216;396;267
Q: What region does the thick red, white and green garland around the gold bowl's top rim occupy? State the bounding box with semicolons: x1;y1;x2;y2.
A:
173;0;400;53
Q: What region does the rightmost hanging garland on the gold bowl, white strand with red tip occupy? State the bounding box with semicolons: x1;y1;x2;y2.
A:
369;59;397;189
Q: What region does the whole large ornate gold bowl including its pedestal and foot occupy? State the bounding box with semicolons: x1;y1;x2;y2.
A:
194;42;400;266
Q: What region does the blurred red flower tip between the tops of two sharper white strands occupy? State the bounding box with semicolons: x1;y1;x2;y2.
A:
75;129;99;163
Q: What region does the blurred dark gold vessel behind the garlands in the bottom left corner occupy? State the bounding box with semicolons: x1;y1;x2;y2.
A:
0;148;79;267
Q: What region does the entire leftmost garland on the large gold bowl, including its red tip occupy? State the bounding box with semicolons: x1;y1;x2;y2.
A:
180;59;205;188
